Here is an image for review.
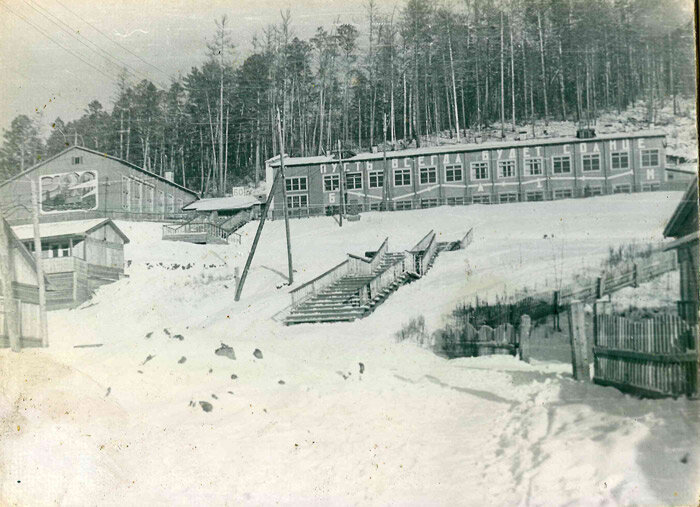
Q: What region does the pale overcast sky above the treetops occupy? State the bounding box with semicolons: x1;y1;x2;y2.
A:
0;0;401;133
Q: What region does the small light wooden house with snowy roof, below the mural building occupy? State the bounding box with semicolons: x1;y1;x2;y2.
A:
13;218;129;310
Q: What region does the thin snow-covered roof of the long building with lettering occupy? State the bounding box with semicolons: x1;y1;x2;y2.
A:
268;130;666;167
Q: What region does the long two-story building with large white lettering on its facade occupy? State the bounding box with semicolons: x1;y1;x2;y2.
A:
267;131;666;218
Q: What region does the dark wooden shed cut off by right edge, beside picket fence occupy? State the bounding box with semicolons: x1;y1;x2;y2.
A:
664;178;700;323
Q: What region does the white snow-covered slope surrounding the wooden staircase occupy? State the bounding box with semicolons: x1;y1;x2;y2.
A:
0;192;700;506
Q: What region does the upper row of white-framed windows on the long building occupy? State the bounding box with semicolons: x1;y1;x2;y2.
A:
286;150;659;192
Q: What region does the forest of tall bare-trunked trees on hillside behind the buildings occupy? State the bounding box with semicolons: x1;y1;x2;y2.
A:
0;0;695;195
